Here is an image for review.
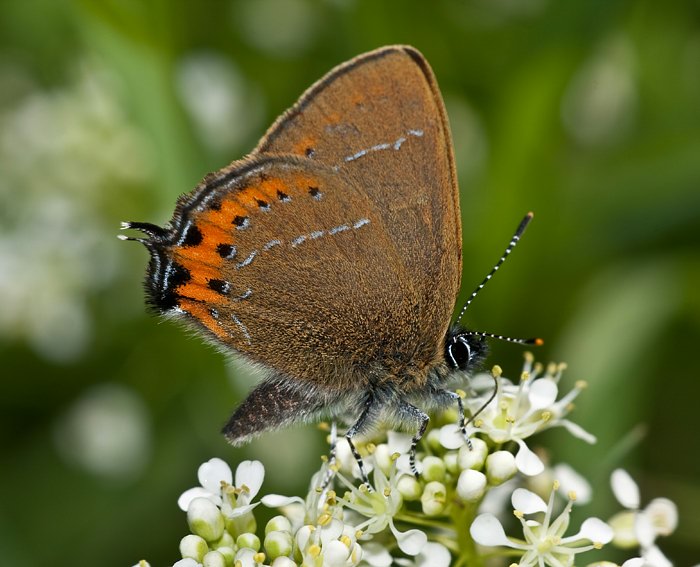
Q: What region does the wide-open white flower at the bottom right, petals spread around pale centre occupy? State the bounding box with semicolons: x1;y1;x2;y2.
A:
470;483;613;567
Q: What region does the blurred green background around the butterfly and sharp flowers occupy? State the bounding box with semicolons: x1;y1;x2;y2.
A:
0;0;700;567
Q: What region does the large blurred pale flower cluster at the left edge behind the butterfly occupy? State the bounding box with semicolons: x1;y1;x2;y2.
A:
0;62;150;361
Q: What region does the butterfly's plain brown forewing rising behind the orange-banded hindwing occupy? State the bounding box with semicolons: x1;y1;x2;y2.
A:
256;46;461;340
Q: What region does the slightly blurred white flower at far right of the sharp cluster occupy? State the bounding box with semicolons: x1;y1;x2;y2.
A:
610;469;678;567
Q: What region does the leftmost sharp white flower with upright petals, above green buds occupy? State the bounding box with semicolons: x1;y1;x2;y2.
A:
177;457;265;518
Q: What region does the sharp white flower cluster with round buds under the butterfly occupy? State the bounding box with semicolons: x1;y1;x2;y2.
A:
131;356;677;567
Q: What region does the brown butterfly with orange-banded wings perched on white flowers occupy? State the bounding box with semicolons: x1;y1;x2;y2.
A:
123;46;538;482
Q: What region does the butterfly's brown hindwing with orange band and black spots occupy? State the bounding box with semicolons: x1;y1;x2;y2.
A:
157;156;438;388
